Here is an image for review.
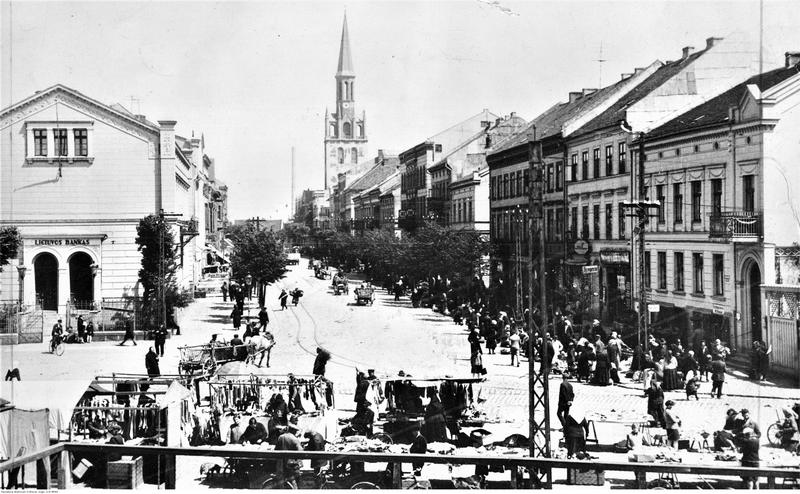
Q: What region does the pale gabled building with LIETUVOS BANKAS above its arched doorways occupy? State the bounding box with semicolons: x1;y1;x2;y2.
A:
0;85;229;341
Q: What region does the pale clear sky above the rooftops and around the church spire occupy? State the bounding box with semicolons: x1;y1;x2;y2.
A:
0;0;800;220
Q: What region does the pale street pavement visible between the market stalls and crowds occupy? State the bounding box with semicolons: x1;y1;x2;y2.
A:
2;262;800;488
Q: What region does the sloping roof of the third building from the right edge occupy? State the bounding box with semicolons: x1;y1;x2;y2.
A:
492;71;640;154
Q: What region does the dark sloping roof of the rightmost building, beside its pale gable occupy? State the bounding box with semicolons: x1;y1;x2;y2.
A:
648;65;800;138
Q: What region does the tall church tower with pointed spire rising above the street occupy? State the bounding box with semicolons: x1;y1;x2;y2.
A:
325;13;367;189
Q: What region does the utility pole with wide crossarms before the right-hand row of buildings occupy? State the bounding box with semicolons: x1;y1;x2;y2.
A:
622;132;661;352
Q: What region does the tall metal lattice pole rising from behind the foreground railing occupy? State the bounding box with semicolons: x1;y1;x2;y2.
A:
528;127;553;489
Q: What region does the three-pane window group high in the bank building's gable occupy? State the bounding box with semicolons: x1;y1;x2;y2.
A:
25;121;94;164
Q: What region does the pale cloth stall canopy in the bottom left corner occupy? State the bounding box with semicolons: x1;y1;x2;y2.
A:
0;380;91;437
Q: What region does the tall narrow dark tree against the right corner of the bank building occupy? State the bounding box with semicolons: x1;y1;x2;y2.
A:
136;214;191;325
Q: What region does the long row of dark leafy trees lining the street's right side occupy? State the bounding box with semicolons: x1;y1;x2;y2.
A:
306;223;490;298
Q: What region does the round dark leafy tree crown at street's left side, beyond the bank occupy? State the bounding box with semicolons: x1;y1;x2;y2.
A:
226;225;287;284
